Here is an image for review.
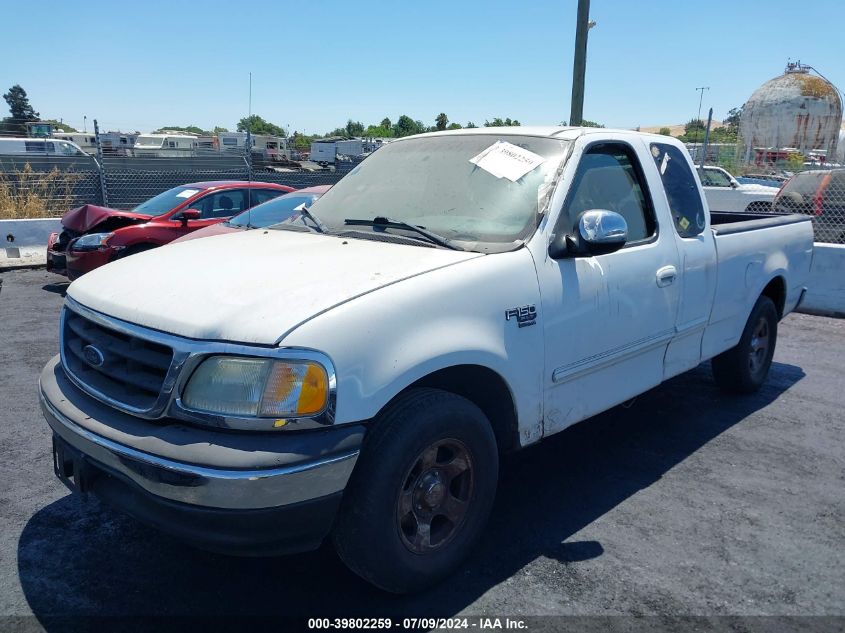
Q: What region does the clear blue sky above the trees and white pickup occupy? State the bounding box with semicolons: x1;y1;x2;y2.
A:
0;0;845;133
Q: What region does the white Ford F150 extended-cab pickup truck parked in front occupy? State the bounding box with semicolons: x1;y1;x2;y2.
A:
40;127;813;592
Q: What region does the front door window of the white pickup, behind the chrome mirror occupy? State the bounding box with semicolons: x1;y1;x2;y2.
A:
561;143;656;242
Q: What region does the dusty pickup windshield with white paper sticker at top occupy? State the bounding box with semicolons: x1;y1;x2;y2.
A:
304;134;568;252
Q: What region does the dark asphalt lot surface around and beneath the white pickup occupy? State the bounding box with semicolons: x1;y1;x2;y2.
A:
0;270;845;630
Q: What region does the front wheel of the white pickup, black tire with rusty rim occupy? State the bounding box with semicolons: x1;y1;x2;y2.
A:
333;389;499;593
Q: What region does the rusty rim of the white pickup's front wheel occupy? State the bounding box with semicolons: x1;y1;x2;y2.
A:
396;439;475;554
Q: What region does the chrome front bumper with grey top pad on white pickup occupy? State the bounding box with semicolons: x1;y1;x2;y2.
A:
39;356;364;510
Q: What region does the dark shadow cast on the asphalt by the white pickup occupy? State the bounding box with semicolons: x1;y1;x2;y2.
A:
18;363;804;630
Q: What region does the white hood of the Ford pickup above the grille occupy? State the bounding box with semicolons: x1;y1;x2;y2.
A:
67;230;482;345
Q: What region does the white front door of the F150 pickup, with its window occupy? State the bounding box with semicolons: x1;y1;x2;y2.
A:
537;138;679;434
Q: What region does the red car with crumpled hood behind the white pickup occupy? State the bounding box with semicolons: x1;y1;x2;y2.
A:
47;180;293;280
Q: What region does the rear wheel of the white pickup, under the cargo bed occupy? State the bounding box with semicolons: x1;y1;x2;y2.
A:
710;296;778;393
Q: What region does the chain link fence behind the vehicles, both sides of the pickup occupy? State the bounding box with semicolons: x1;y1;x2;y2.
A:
0;124;845;244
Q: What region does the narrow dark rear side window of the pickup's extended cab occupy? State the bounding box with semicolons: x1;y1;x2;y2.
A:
650;143;707;237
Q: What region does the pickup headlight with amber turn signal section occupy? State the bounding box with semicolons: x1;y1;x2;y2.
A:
182;356;329;418
